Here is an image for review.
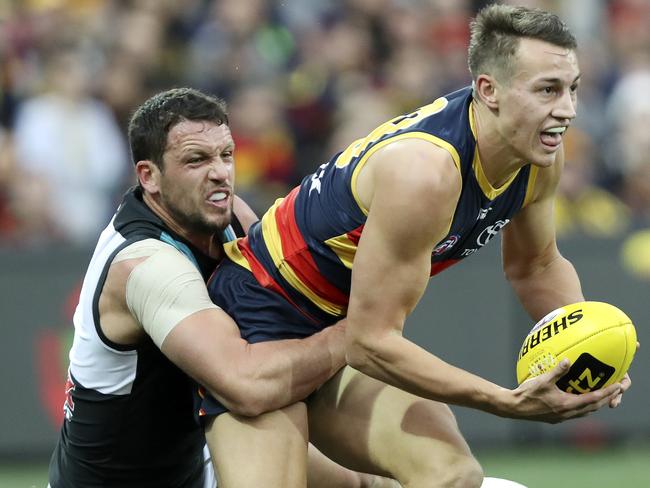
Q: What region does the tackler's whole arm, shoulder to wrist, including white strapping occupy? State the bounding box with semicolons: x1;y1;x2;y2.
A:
100;239;345;415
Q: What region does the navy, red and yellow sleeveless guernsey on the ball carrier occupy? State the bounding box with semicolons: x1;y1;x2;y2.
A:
220;87;537;325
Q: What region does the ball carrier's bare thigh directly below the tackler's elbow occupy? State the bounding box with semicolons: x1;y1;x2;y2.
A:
205;402;308;488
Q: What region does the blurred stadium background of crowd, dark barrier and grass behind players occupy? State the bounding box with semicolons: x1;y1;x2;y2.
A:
0;0;650;488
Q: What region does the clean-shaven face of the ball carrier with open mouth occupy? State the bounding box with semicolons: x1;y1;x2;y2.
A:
499;39;580;167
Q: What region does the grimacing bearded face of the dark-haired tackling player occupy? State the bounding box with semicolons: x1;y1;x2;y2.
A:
160;120;235;235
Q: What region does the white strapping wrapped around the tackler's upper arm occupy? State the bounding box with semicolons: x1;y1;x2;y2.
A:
123;239;219;348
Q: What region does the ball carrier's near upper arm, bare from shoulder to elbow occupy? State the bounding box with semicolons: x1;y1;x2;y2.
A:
348;141;460;335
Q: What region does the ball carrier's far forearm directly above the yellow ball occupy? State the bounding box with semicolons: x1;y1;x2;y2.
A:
506;254;584;321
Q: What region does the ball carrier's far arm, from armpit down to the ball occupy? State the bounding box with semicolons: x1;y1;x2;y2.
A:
501;149;584;322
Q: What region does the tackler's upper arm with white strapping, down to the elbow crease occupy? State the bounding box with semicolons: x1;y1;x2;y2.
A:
126;247;256;406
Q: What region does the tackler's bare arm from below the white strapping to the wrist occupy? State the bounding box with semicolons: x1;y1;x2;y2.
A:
161;308;345;416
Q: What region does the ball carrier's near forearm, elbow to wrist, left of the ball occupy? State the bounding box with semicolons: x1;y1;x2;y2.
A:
347;333;512;416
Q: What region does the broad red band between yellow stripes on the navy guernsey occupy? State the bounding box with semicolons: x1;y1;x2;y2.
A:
275;187;352;306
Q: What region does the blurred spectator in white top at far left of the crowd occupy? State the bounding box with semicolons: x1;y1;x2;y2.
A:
14;50;128;244
